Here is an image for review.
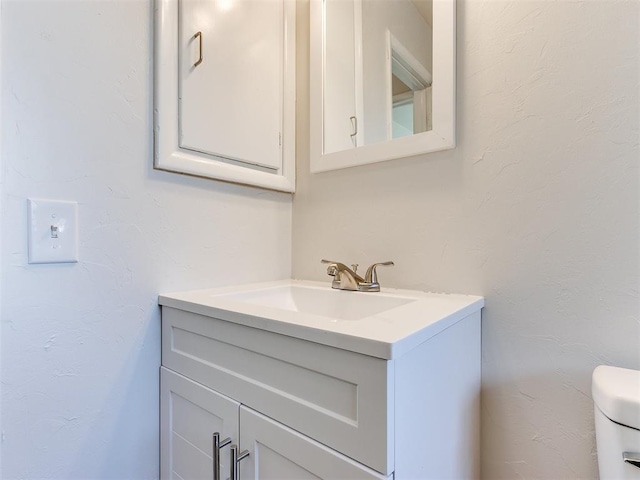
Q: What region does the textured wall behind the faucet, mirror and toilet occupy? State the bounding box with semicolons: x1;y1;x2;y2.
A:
293;0;640;479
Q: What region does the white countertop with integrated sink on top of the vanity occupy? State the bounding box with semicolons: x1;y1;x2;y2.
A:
158;280;484;359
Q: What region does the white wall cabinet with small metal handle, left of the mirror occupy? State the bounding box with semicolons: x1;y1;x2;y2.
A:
154;0;295;192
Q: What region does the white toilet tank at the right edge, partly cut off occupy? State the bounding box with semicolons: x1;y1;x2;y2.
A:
592;365;640;480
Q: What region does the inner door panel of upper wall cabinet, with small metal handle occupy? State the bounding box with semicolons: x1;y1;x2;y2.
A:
179;0;285;171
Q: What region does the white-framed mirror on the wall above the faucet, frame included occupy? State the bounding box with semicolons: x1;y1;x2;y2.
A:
310;0;455;172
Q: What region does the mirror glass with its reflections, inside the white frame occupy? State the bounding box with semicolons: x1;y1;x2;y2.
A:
323;0;433;153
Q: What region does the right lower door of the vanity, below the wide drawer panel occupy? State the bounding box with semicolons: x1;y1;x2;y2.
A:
239;406;393;480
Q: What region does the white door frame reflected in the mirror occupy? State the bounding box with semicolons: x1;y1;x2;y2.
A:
386;29;433;140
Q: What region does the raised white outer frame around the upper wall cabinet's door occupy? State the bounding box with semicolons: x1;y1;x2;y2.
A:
153;0;296;192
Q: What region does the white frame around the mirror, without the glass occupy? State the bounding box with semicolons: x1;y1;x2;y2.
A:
309;0;456;173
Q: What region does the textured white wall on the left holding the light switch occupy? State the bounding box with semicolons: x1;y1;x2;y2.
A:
0;0;291;479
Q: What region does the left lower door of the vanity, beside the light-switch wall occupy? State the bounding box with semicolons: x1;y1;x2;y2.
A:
160;367;239;480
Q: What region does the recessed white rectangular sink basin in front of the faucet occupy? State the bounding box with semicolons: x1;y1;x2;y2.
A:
215;285;416;321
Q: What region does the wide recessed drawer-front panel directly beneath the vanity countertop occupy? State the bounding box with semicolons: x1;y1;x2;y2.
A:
162;306;394;475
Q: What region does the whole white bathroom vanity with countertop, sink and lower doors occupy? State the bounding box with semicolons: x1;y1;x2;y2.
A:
159;280;484;480
